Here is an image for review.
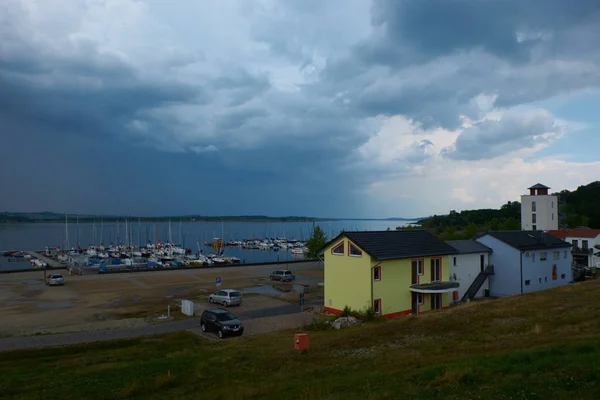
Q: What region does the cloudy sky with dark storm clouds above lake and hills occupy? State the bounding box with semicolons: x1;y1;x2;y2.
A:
0;0;600;218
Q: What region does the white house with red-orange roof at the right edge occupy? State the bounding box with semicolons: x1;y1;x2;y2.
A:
548;228;600;268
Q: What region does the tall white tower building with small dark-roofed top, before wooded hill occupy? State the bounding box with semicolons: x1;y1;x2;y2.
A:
521;183;559;231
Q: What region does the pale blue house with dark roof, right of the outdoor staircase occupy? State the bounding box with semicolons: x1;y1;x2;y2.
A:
475;231;573;296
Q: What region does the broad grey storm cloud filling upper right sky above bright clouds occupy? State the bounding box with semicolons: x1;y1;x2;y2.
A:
316;0;600;133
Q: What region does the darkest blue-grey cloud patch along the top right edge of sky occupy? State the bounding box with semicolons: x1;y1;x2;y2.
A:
372;0;600;63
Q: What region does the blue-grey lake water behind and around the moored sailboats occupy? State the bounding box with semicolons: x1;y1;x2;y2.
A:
0;220;418;269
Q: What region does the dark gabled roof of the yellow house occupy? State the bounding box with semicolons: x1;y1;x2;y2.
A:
319;230;457;260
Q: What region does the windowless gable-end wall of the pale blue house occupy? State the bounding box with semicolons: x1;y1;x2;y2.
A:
476;235;521;296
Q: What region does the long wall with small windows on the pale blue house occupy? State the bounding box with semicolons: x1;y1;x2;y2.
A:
523;249;573;293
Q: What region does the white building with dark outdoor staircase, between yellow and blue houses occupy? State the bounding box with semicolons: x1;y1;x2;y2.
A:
446;240;492;301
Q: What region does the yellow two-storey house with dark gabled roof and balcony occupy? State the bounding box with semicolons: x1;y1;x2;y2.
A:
319;230;458;318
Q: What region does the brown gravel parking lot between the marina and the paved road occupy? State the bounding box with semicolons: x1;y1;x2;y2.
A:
0;262;323;340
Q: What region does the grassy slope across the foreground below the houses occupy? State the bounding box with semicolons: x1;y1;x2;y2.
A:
0;281;600;400
